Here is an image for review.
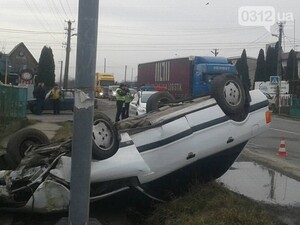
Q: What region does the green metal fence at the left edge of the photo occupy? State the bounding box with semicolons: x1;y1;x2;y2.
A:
0;83;27;125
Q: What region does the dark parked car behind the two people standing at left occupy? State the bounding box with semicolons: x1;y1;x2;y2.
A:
28;89;74;114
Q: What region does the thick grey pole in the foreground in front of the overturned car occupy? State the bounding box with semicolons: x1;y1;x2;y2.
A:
58;0;100;225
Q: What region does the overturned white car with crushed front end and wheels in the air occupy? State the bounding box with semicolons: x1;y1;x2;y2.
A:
0;75;270;213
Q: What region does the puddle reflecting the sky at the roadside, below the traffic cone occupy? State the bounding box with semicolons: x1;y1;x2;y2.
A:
218;162;300;207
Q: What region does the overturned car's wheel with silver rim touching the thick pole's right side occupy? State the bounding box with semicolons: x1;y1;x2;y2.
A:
92;112;120;160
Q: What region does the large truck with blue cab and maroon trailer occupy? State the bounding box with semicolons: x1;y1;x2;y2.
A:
137;56;237;99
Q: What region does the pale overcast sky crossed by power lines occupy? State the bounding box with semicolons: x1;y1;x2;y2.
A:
0;0;300;81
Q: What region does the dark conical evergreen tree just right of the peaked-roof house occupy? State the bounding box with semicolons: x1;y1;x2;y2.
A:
37;46;55;87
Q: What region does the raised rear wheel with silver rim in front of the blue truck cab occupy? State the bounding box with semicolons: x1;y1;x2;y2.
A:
211;74;246;115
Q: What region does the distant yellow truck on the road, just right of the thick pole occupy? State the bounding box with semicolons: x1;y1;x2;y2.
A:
95;73;115;98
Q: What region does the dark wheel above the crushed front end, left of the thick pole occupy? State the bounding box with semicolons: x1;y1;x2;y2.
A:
6;128;50;166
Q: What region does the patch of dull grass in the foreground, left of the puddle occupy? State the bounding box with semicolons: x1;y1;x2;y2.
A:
143;182;284;225
